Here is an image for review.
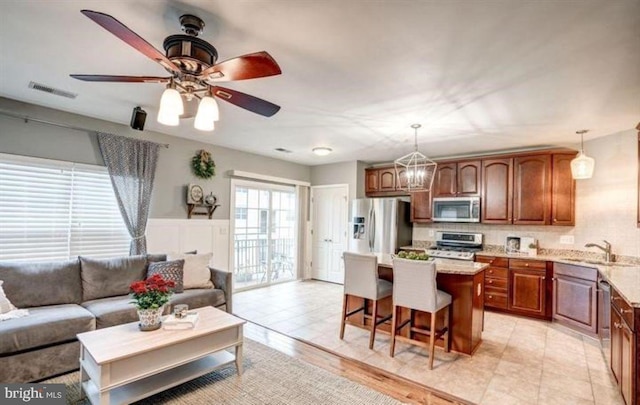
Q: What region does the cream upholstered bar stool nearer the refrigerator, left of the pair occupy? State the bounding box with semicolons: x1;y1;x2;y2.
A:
340;252;393;349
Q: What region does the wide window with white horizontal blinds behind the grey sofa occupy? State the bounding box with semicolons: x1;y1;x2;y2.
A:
0;154;130;261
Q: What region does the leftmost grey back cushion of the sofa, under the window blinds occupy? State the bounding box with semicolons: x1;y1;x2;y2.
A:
0;259;82;308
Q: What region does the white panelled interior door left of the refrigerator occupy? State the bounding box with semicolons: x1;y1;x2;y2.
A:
311;184;349;283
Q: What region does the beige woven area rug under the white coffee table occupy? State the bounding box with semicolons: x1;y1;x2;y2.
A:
43;337;400;405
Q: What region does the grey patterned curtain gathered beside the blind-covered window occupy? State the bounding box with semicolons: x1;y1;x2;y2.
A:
98;134;160;255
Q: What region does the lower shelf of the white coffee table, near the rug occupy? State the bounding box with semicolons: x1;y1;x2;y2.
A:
82;350;236;405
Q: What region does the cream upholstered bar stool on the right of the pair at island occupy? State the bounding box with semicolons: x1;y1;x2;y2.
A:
390;258;451;370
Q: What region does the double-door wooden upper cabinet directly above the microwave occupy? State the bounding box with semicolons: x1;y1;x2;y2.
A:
432;160;481;197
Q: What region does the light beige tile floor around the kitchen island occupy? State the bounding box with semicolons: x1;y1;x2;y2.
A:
233;281;623;405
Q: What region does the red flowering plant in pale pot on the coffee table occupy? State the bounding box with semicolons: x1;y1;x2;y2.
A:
129;274;175;331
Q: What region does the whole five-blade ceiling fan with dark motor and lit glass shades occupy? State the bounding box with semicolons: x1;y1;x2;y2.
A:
70;10;282;130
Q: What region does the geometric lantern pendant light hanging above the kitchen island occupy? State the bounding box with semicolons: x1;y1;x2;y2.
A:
393;124;438;191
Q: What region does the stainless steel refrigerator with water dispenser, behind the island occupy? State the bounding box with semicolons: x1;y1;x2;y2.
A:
349;198;413;253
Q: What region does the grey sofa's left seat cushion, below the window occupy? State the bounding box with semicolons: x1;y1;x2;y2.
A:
0;304;96;354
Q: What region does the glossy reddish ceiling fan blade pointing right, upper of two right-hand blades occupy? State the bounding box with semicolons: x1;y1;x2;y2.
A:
200;51;282;82
